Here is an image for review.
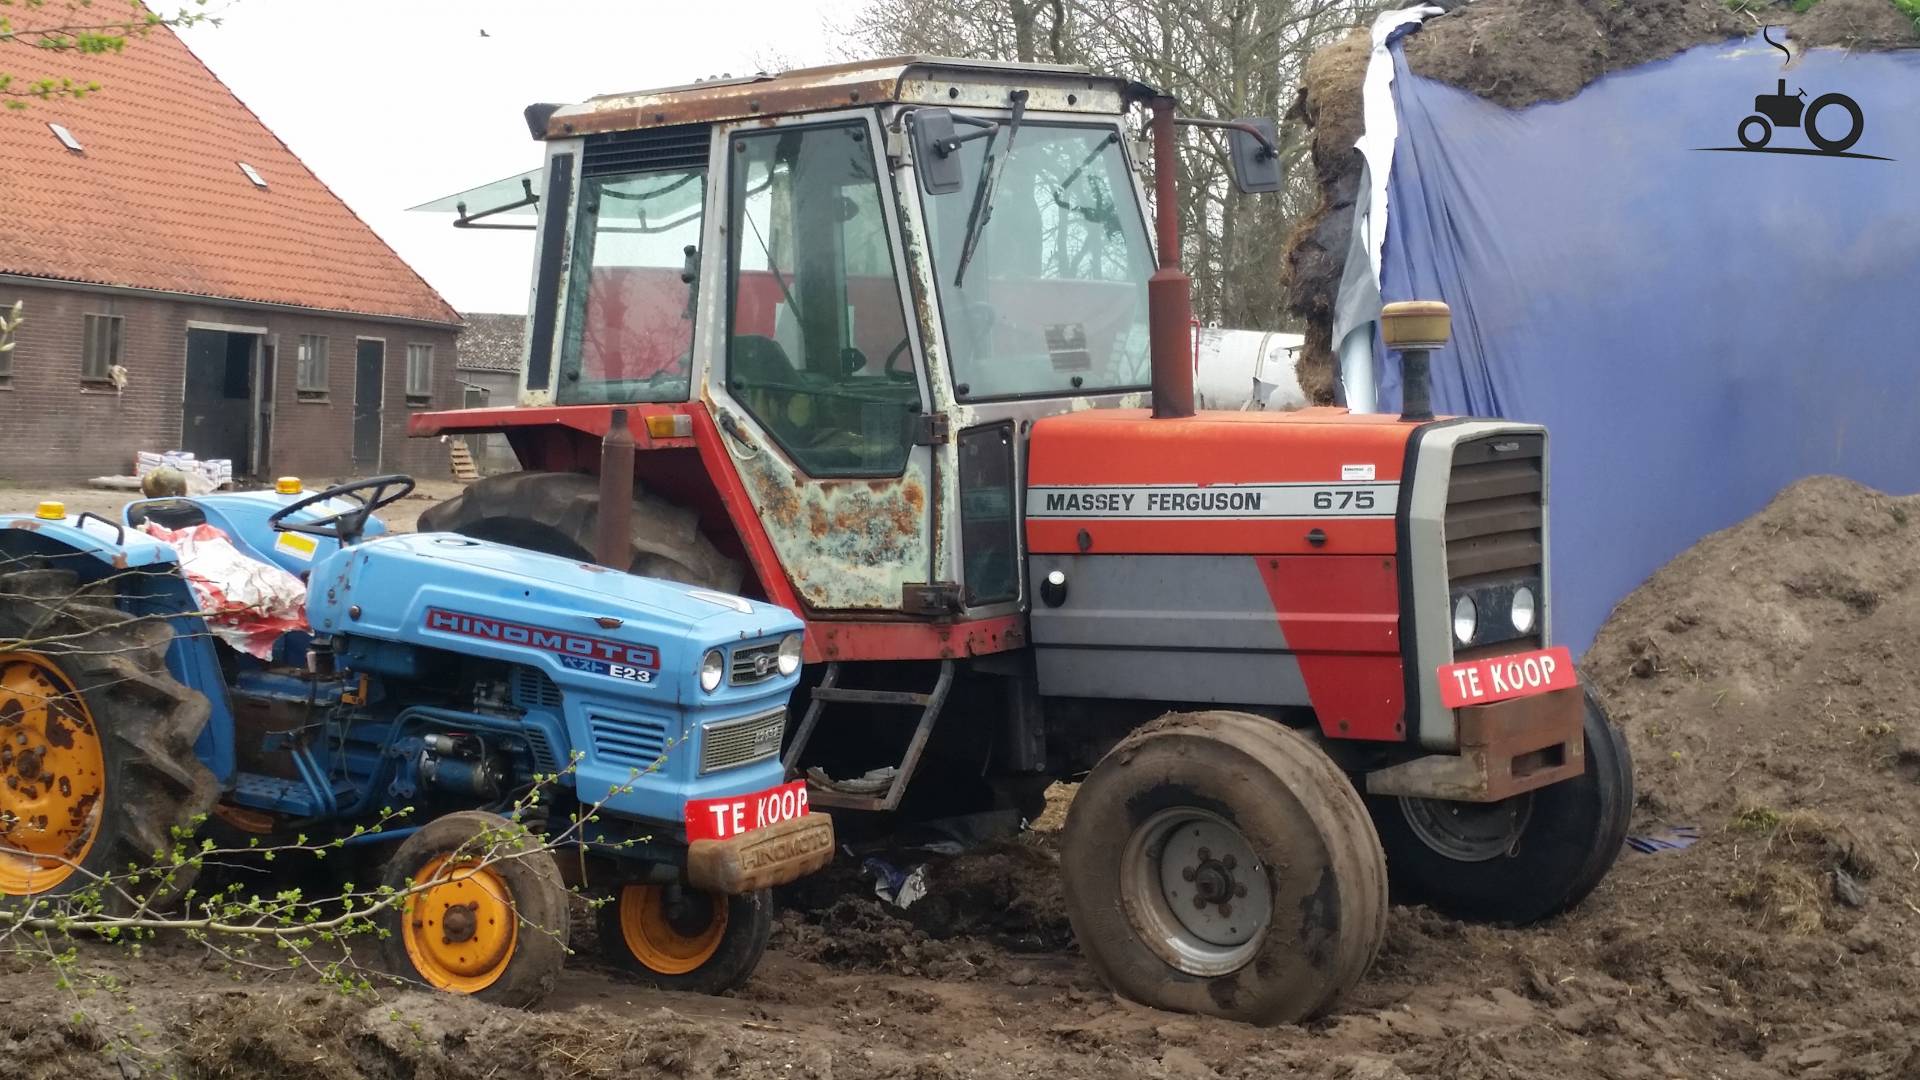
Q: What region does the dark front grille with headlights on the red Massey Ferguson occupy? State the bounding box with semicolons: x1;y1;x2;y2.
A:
1444;434;1546;659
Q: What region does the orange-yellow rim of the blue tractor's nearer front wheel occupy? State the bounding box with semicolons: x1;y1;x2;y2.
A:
399;855;520;994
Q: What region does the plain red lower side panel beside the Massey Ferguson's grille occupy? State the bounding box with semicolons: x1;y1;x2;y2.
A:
1256;555;1405;742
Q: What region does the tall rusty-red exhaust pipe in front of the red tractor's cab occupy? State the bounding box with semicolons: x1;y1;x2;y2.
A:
1146;94;1194;419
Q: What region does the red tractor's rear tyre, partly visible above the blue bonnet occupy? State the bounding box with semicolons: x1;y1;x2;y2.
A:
420;473;741;592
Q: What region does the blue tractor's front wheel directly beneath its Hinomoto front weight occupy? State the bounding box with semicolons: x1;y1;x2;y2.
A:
599;884;774;994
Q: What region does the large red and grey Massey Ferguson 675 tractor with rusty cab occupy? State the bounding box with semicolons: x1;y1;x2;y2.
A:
413;58;1632;1022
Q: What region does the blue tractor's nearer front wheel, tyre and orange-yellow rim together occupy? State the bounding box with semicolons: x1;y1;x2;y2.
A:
380;811;568;1009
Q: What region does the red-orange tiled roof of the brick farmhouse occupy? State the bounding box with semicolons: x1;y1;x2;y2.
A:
0;19;461;323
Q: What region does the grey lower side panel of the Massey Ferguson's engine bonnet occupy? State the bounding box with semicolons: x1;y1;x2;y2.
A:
1027;555;1309;705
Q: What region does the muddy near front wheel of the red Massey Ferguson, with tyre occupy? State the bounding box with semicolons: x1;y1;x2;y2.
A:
1062;711;1386;1024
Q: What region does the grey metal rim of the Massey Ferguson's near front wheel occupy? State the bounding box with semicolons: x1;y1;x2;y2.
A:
1121;807;1273;976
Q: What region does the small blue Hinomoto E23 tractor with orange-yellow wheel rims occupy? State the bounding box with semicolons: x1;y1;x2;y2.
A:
0;477;833;1005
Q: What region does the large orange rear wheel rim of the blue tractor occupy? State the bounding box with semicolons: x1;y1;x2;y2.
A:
0;653;108;896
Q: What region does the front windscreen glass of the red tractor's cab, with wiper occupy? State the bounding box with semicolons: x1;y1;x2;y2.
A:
922;121;1154;402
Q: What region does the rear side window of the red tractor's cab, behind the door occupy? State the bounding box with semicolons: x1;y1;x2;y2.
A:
553;169;707;405
